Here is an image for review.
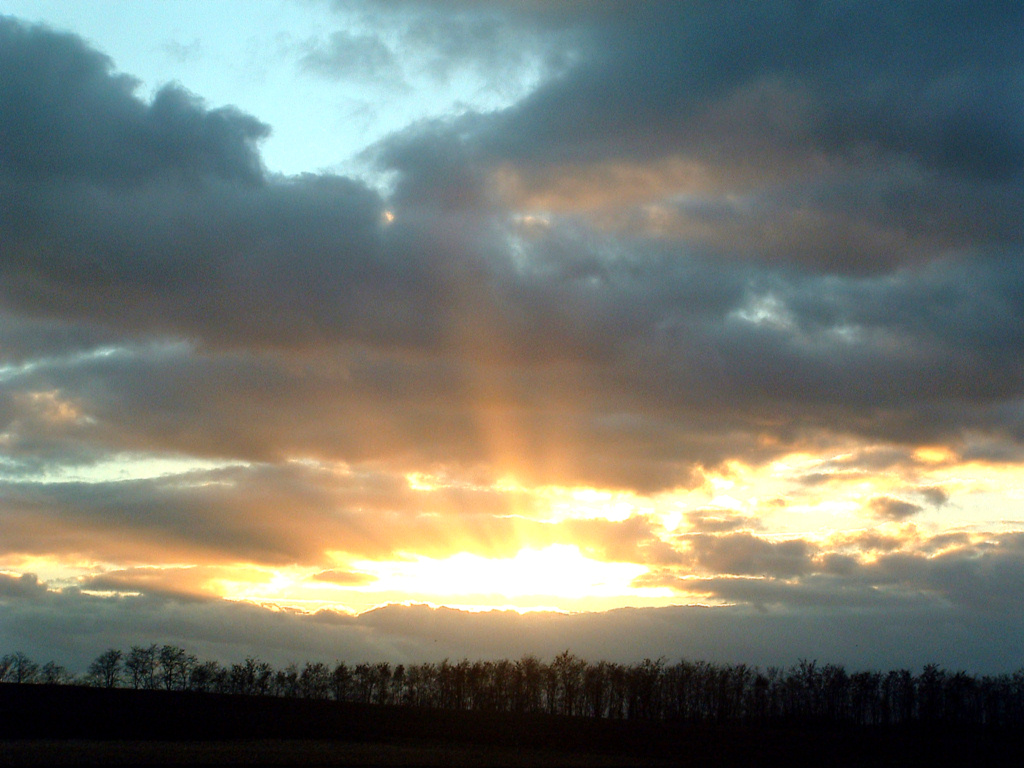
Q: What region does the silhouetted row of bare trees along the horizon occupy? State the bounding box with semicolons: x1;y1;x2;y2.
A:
0;644;1024;727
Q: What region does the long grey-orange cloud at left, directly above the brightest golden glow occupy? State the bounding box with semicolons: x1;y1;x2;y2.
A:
0;465;503;569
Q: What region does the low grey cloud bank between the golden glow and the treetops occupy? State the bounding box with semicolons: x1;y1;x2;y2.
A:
0;590;1022;674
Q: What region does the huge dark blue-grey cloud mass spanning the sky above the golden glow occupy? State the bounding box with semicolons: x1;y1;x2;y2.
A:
6;3;1024;489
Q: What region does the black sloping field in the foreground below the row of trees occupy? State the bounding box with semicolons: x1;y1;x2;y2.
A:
0;684;1024;766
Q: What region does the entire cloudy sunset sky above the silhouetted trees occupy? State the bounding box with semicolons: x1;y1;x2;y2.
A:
0;0;1024;673
